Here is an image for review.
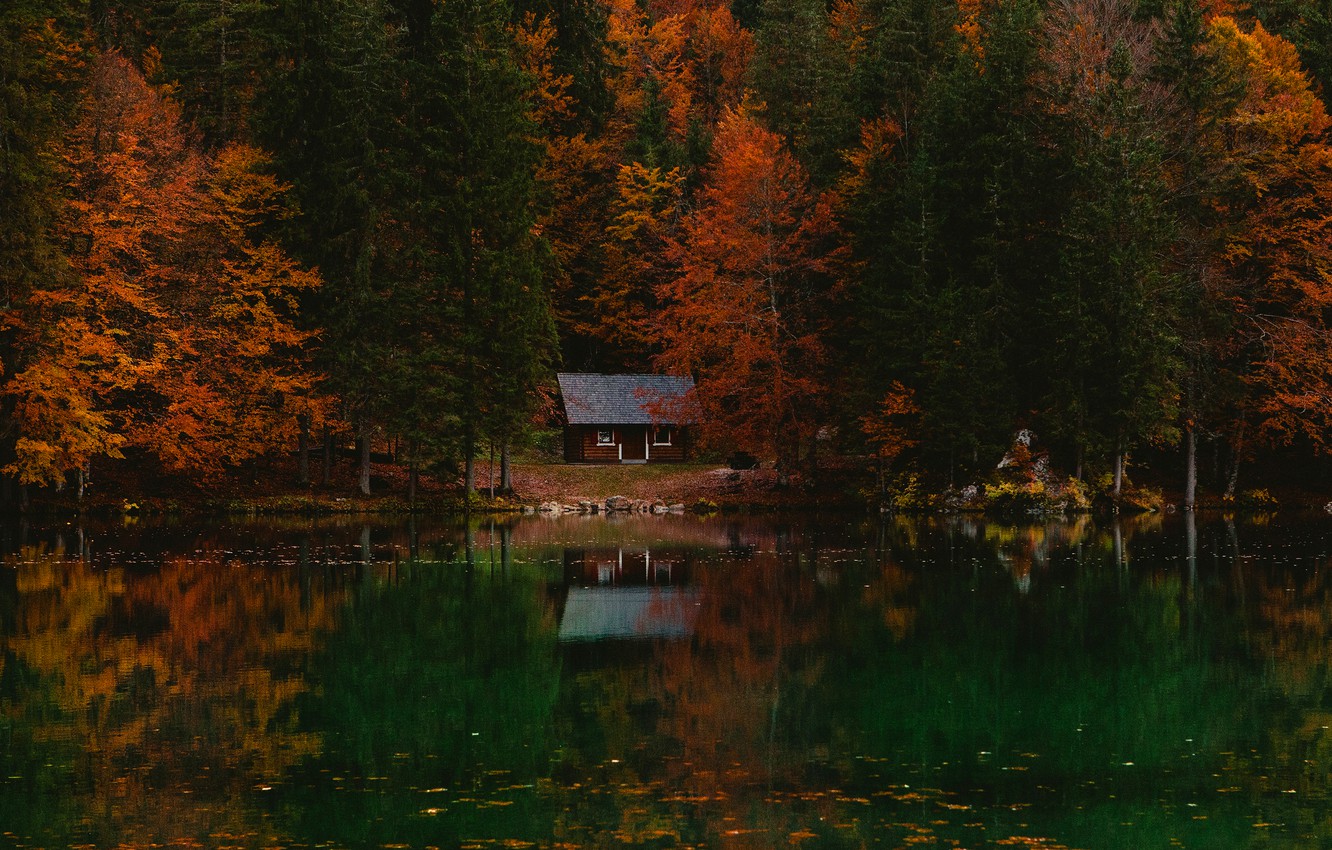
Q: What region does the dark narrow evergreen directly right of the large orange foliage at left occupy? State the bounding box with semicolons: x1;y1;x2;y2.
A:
257;0;404;493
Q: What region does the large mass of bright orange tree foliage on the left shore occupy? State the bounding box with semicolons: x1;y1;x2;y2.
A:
5;53;318;482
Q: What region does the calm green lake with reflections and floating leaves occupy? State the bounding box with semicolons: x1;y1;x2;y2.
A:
0;516;1332;849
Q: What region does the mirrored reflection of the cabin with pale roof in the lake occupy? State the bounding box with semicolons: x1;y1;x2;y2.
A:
559;548;699;643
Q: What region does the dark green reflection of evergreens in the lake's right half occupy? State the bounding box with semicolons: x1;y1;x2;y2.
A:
829;520;1247;846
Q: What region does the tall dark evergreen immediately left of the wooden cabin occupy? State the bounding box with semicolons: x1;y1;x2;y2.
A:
393;0;554;485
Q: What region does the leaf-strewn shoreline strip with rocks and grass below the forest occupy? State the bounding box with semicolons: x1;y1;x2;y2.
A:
12;458;1332;520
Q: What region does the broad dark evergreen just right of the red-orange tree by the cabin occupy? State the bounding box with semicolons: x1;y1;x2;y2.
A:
850;0;1058;482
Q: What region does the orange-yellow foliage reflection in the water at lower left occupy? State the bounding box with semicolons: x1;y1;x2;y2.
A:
0;553;340;841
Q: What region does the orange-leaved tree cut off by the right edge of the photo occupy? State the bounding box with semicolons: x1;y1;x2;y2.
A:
1208;23;1332;455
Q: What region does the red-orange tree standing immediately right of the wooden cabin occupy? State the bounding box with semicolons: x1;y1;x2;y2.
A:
657;111;842;481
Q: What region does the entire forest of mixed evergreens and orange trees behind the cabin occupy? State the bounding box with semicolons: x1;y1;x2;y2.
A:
0;0;1332;504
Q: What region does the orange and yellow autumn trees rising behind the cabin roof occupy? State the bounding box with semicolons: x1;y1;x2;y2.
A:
538;0;754;370
